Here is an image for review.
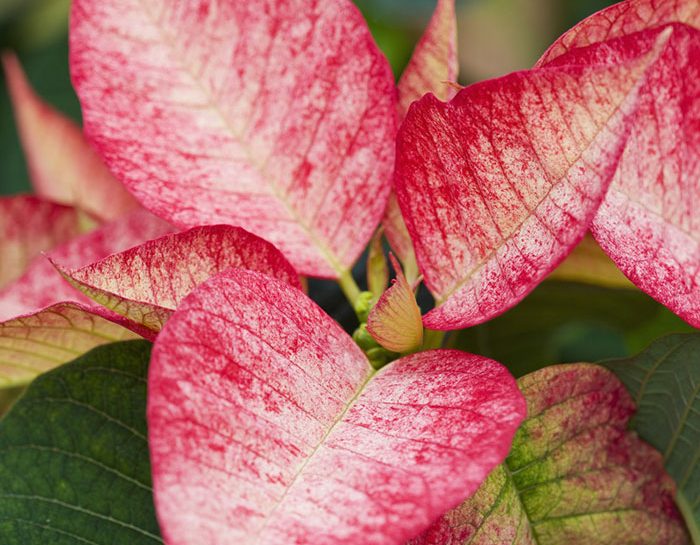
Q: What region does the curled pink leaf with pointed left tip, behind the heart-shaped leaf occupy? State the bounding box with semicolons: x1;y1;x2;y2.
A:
57;225;301;333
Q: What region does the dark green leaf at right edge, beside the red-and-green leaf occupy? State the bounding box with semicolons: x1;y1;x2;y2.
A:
604;333;700;543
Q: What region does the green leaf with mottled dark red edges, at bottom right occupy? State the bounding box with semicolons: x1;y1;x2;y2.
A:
409;364;689;545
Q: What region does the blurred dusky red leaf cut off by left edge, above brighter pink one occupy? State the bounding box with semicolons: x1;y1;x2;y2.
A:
0;196;81;289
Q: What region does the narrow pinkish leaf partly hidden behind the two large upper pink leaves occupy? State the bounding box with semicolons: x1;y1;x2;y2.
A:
384;0;459;282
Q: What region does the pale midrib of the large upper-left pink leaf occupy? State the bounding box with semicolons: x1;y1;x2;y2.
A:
139;0;346;275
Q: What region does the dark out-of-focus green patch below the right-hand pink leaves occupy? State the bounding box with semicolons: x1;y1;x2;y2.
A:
450;281;693;376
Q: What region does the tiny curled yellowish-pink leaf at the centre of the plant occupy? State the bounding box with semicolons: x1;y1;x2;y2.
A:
367;254;423;354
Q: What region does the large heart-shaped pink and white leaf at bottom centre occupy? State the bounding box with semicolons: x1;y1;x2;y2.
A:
148;270;524;545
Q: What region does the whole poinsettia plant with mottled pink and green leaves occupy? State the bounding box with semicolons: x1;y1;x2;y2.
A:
0;0;700;545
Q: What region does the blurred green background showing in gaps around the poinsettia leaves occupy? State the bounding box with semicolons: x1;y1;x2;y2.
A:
0;0;692;375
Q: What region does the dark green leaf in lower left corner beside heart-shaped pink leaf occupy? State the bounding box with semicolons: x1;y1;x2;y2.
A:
0;341;162;545
